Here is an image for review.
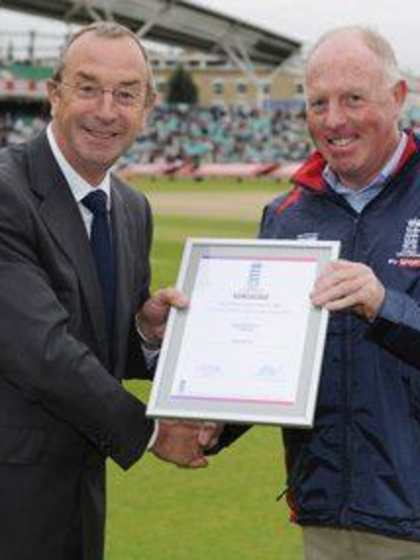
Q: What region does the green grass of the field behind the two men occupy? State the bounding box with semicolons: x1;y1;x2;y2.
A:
106;180;301;560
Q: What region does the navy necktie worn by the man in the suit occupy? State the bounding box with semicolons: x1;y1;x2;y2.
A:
82;189;115;349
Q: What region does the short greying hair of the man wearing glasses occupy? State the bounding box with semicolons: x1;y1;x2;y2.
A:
52;21;156;108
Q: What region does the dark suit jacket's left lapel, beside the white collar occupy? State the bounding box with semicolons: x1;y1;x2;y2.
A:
29;132;107;357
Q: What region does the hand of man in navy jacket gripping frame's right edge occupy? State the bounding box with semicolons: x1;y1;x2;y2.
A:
311;260;385;321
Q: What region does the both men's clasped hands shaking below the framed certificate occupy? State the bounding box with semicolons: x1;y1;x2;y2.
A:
150;420;223;469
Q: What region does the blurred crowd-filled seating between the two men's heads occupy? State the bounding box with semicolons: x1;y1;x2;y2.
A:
119;105;311;171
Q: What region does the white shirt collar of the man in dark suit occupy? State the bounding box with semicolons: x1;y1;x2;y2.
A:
47;123;111;211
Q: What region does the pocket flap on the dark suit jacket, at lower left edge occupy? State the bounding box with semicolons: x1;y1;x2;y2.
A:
0;427;46;465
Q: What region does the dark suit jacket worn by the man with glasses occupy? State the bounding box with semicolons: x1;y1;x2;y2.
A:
0;129;153;560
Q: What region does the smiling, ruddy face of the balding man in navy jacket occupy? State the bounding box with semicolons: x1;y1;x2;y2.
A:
306;32;406;189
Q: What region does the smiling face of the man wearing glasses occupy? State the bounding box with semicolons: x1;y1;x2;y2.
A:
48;32;152;185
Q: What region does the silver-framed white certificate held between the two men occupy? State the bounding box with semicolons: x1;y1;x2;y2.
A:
147;239;339;427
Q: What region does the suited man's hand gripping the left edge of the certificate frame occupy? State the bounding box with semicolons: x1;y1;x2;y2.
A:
136;288;188;342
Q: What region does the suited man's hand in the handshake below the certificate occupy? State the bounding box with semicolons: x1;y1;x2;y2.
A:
151;420;208;468
